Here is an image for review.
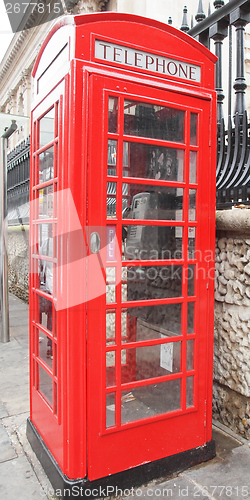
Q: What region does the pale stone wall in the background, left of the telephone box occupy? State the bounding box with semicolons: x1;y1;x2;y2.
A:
8;226;29;302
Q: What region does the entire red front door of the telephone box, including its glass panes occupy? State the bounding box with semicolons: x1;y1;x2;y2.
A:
87;75;214;480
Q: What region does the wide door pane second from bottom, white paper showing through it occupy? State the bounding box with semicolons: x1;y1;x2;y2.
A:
121;342;181;384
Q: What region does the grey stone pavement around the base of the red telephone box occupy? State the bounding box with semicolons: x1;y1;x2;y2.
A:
0;296;250;500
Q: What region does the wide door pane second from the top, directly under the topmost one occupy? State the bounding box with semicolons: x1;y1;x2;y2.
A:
123;142;184;182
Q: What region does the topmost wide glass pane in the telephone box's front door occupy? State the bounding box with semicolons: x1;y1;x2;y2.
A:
124;101;185;142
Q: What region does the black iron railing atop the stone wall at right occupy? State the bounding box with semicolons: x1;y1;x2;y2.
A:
181;0;250;209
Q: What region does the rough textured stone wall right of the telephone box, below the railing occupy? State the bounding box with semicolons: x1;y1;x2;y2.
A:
213;209;250;439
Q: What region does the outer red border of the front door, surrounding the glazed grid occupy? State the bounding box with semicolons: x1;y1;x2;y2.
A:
87;71;215;480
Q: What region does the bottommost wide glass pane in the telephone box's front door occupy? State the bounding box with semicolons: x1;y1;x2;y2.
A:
121;379;181;424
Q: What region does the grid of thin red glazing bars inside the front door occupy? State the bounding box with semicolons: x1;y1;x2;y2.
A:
104;98;198;431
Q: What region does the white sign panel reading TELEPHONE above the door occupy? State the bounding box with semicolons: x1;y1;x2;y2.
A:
95;39;201;83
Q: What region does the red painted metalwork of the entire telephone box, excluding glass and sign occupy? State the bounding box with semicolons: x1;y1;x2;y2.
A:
30;13;216;480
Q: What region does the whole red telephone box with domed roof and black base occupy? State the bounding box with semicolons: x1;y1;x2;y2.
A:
28;12;216;497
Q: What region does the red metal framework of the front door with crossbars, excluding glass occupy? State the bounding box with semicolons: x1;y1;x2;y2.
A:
87;75;214;480
